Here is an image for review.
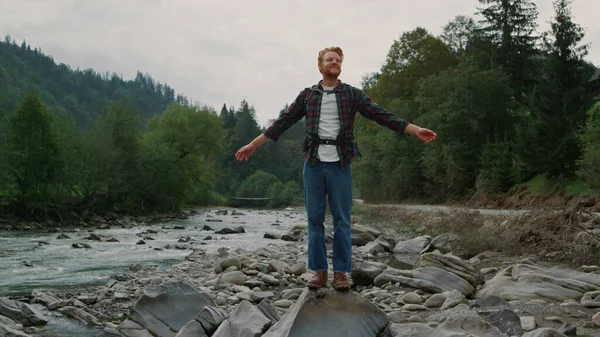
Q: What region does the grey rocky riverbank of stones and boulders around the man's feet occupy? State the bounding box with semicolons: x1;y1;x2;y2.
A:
0;207;600;337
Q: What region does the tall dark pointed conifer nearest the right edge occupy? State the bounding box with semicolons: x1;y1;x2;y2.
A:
520;0;594;178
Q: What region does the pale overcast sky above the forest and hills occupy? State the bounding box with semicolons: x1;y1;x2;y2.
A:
0;0;600;125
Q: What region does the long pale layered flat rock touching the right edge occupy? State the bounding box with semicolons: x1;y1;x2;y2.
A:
475;264;600;302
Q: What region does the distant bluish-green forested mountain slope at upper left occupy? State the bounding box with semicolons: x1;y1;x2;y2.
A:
0;36;190;126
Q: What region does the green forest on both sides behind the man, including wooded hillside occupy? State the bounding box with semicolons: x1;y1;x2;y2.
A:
0;0;600;218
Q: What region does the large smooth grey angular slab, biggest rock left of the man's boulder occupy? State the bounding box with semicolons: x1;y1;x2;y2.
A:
130;282;216;337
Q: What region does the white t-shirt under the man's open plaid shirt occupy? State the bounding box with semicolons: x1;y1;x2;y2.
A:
318;86;340;162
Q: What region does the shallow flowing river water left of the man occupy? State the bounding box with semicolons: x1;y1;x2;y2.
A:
0;209;306;337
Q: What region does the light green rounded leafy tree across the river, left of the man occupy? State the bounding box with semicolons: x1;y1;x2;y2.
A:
136;105;224;209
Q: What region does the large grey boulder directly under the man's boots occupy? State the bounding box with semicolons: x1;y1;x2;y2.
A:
263;288;392;337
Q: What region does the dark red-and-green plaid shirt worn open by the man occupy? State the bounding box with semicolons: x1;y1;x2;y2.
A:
264;80;408;166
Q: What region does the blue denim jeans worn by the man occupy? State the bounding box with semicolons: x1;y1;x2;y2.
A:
303;161;352;273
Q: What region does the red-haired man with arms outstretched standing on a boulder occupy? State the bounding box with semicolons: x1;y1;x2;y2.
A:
235;47;437;290
